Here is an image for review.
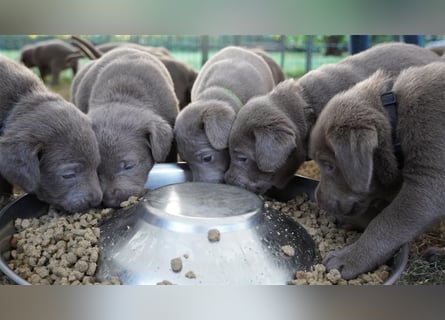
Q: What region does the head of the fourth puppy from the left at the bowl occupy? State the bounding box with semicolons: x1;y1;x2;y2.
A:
225;97;306;193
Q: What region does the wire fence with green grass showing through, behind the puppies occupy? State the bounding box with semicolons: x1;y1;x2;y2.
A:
0;35;444;76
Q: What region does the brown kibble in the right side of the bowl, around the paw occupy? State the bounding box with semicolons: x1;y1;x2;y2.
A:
265;195;391;285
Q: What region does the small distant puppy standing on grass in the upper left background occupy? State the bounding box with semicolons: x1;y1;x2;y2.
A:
20;39;79;85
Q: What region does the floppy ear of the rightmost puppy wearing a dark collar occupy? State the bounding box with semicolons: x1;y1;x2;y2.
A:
329;129;378;193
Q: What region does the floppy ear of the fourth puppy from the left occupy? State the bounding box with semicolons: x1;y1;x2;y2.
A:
253;123;297;172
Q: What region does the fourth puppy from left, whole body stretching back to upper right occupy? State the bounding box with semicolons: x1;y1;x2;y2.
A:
225;43;440;193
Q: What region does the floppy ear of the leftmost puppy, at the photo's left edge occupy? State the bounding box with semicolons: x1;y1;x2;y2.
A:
0;141;40;192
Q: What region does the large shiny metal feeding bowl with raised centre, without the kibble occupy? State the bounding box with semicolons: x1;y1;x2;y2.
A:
0;164;408;285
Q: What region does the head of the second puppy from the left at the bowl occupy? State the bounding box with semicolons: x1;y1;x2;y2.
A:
90;106;173;207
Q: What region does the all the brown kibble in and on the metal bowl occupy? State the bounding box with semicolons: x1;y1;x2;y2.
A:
3;188;391;285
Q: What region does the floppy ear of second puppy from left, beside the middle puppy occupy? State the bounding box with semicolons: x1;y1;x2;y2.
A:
147;121;173;162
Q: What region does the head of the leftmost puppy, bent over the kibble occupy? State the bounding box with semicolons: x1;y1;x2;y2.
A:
0;99;102;212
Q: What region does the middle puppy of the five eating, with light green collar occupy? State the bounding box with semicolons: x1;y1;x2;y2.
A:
174;46;274;183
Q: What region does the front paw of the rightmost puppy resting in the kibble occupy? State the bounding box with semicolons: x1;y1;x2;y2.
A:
323;244;375;280
